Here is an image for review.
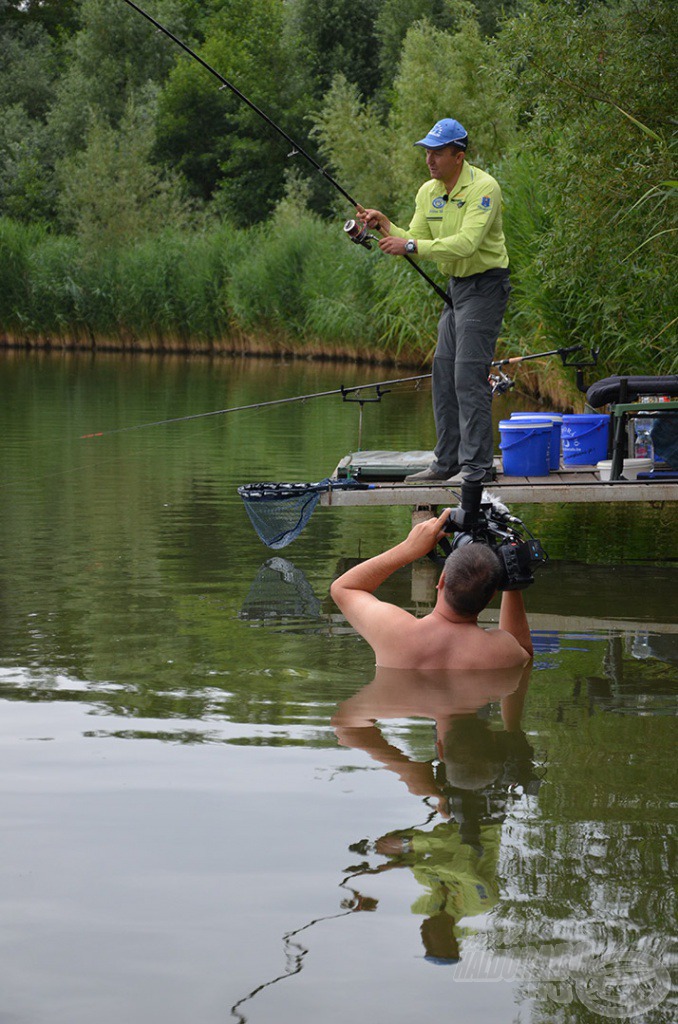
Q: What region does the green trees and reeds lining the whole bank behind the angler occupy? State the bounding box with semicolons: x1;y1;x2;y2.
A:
0;0;678;393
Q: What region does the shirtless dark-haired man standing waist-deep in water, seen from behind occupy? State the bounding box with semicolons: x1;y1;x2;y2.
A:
330;509;534;670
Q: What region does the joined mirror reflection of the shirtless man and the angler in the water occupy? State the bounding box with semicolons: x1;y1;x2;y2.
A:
333;665;534;964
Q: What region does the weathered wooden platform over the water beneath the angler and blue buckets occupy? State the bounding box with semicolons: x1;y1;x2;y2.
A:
321;467;678;508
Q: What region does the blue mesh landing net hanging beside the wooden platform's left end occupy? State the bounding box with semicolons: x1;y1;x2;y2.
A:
238;477;365;549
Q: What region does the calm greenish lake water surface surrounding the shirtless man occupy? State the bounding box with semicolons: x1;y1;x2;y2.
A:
0;353;678;1024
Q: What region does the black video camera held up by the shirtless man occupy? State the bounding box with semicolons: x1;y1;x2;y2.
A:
439;481;548;590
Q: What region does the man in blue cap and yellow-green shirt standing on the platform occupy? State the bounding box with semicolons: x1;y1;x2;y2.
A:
357;118;511;483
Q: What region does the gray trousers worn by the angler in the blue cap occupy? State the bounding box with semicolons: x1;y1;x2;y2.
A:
432;268;511;480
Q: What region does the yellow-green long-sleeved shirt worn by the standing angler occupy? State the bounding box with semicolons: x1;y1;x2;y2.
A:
390;162;509;278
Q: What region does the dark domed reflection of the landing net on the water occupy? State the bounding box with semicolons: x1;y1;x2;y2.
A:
239;558;321;620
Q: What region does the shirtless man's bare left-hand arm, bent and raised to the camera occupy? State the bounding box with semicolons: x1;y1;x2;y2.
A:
330;509;450;650
